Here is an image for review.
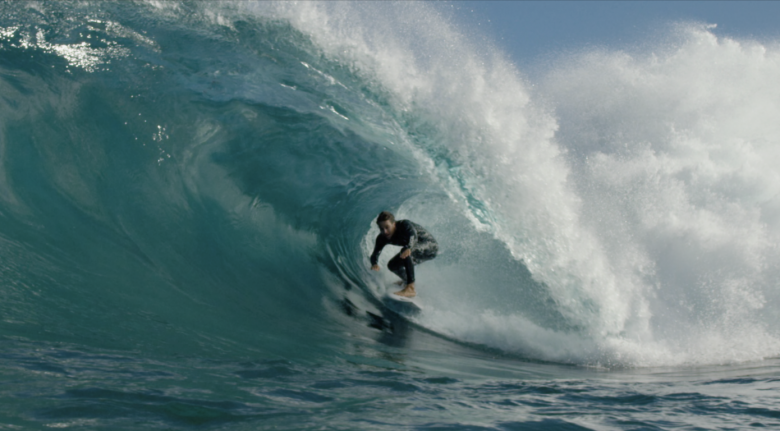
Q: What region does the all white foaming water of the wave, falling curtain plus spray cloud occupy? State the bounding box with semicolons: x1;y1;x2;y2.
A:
184;2;780;366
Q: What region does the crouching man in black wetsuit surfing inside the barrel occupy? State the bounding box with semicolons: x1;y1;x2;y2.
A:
371;211;439;298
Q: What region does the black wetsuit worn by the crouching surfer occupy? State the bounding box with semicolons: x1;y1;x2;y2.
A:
371;220;439;284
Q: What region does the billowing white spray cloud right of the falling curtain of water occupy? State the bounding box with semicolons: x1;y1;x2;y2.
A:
539;25;780;363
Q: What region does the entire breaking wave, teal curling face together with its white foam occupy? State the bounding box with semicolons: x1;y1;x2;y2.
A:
0;2;780;366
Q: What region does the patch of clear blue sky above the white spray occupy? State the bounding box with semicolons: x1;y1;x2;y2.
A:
453;1;780;65
